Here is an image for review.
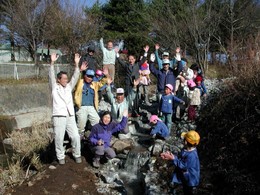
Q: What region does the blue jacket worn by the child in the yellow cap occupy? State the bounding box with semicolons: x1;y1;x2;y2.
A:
172;148;200;186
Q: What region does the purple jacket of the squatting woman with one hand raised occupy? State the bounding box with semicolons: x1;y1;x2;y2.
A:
89;117;127;148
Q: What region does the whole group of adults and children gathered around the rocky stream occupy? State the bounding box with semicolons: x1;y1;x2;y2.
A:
49;38;203;195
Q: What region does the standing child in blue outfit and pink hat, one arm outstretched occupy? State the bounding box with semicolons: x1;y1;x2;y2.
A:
159;84;185;132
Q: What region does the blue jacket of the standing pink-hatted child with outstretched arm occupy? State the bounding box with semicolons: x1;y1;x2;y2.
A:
159;94;183;114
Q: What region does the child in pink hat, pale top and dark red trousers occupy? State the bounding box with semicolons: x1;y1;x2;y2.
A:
187;80;201;122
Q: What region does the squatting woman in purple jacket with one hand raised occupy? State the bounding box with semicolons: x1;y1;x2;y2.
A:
89;111;127;168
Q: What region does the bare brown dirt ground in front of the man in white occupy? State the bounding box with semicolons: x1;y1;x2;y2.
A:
6;156;99;195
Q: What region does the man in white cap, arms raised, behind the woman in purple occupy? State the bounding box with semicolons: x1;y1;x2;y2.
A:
106;76;139;133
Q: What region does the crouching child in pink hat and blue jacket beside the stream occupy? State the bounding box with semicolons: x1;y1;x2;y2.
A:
150;115;169;139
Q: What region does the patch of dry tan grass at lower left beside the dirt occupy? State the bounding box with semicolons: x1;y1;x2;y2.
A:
0;120;51;194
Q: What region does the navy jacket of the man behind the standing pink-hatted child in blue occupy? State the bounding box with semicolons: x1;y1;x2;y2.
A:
150;63;176;93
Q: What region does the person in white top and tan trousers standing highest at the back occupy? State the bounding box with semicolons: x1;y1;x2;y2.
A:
100;38;116;81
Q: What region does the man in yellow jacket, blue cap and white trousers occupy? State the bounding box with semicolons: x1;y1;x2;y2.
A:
74;69;108;135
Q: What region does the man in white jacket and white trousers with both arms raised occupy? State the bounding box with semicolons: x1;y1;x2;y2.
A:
49;53;87;165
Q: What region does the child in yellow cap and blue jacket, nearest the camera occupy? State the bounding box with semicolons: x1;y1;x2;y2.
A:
161;130;200;195
